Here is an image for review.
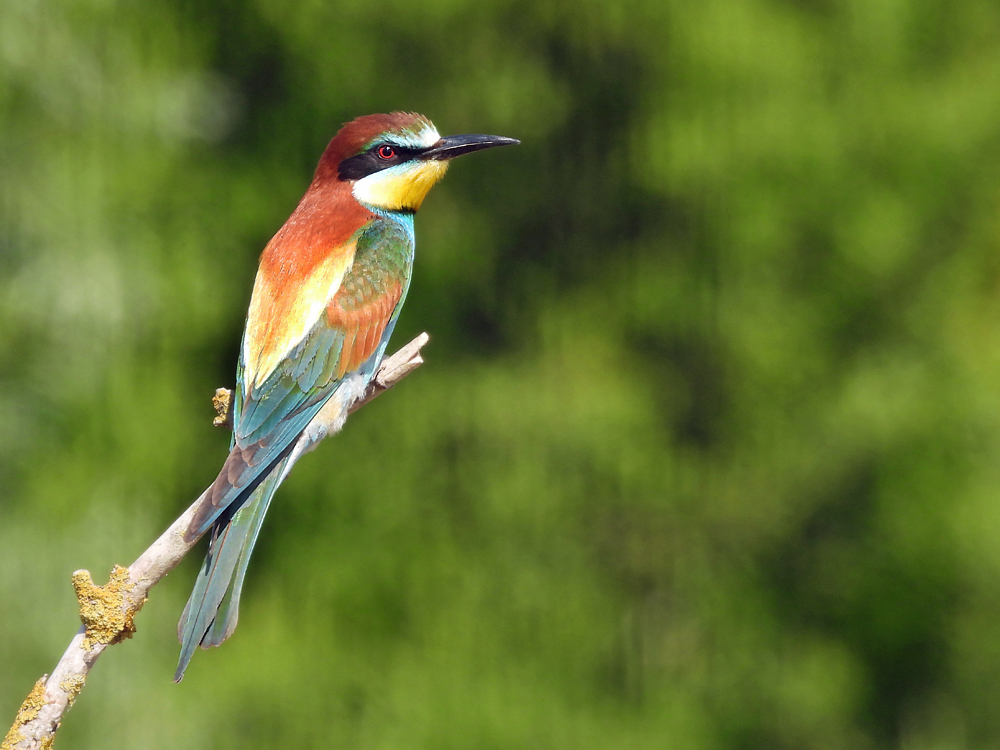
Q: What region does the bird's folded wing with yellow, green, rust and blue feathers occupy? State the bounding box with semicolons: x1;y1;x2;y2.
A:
187;219;413;537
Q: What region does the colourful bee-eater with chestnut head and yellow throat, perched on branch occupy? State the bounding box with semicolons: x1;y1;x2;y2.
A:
174;112;519;682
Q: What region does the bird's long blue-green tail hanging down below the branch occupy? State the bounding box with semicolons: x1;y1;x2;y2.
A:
174;458;288;682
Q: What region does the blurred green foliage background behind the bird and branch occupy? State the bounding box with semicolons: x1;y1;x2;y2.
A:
0;0;1000;750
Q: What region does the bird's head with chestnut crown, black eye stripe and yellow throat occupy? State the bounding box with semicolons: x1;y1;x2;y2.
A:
316;112;519;212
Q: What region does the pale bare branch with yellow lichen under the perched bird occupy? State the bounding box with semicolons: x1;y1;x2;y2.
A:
0;333;430;750
